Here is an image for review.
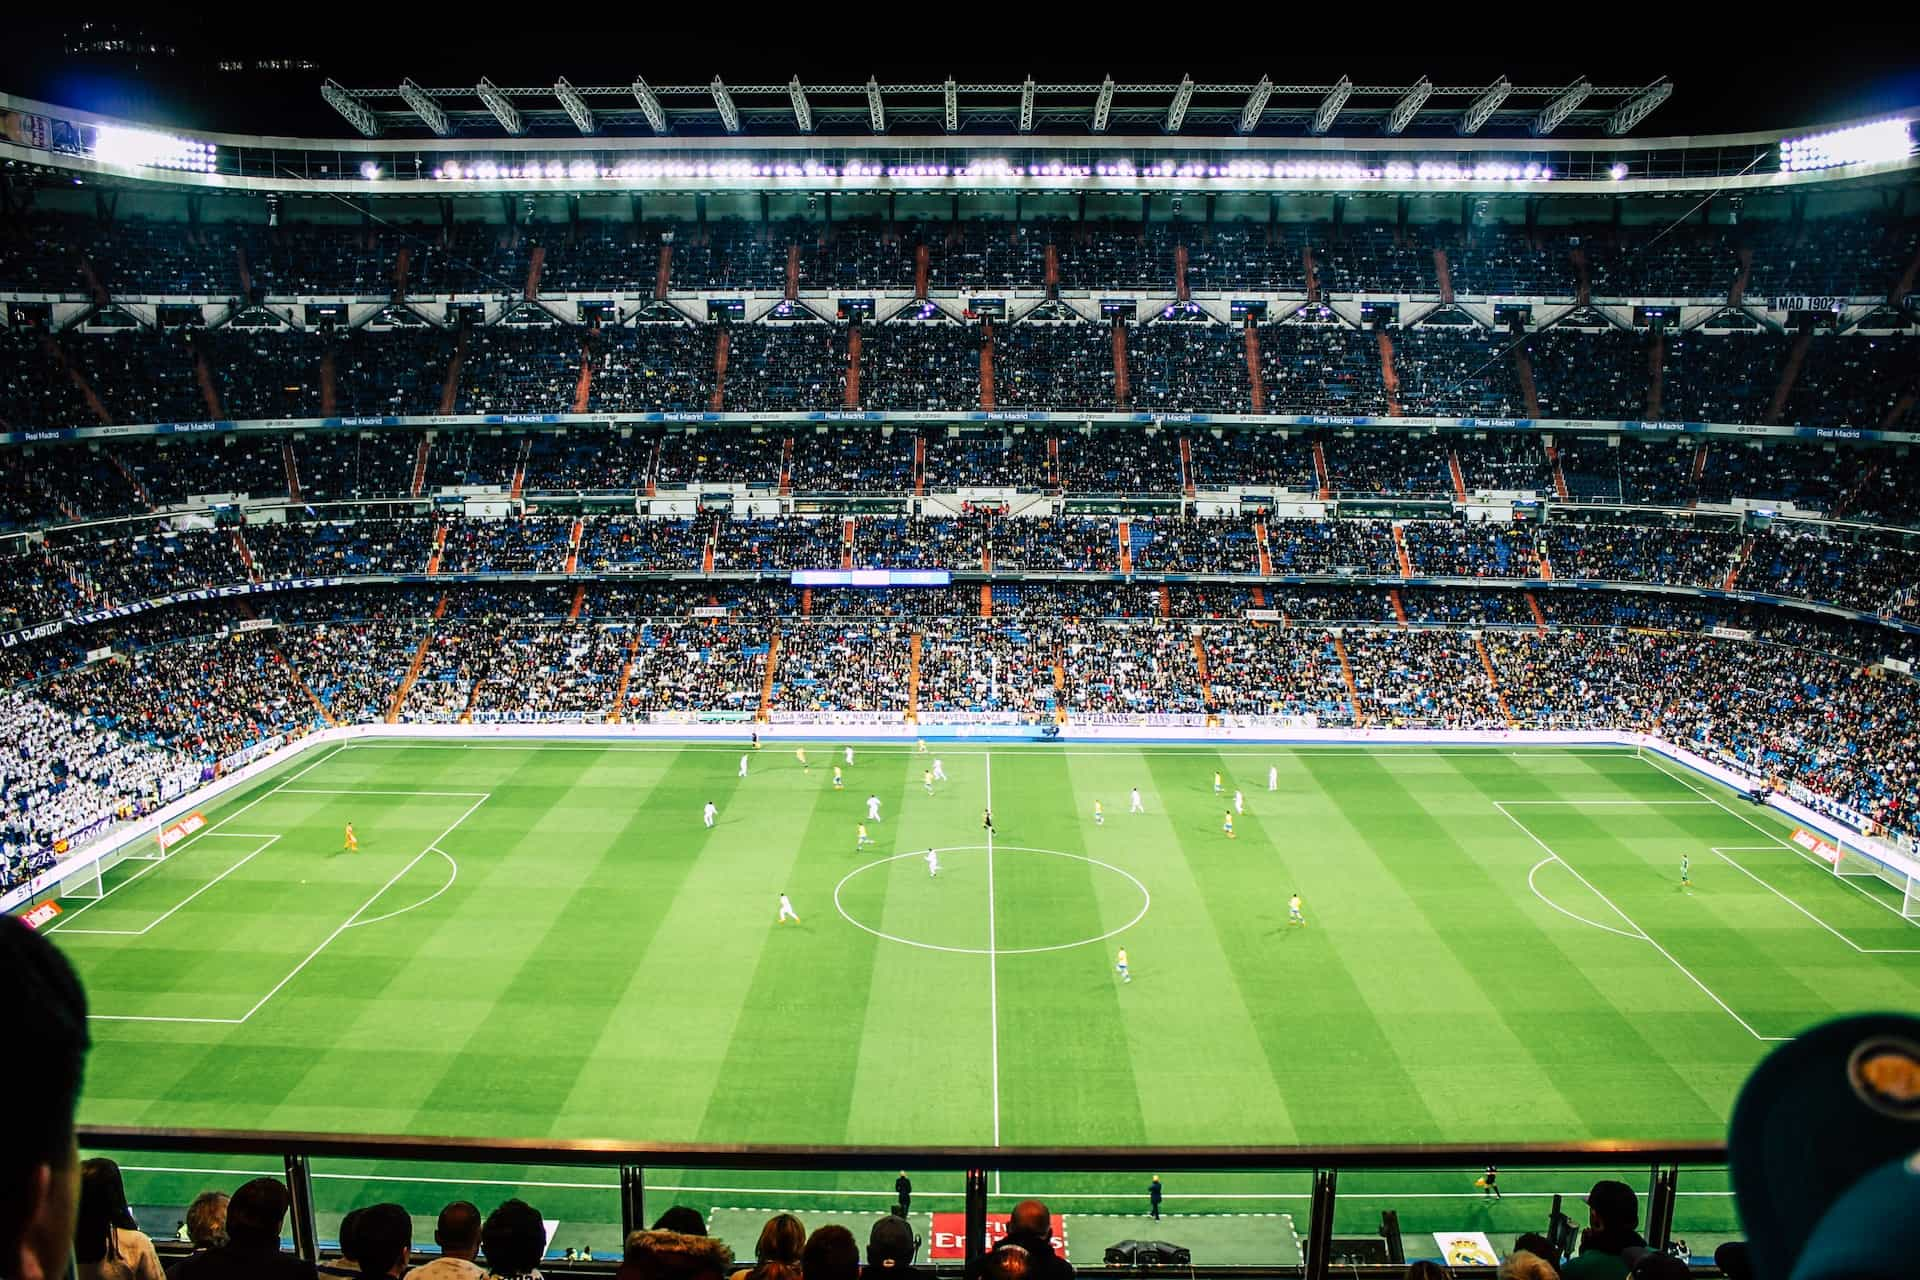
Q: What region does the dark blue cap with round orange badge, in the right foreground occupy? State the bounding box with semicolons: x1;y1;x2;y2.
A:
1728;1013;1920;1280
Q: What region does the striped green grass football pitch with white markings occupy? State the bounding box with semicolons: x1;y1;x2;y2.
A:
52;739;1920;1261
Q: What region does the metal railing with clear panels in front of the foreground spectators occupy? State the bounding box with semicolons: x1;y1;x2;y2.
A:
79;1126;1740;1280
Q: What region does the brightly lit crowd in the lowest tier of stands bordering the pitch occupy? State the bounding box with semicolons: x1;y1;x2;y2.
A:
0;571;1920;890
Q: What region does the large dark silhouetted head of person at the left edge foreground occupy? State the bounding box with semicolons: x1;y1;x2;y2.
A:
0;915;86;1280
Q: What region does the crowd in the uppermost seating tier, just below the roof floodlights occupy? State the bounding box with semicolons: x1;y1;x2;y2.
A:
0;213;1916;299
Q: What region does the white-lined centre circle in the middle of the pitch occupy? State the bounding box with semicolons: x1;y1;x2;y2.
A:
833;844;1154;956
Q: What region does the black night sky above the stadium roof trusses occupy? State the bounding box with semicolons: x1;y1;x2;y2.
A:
11;20;1920;136
